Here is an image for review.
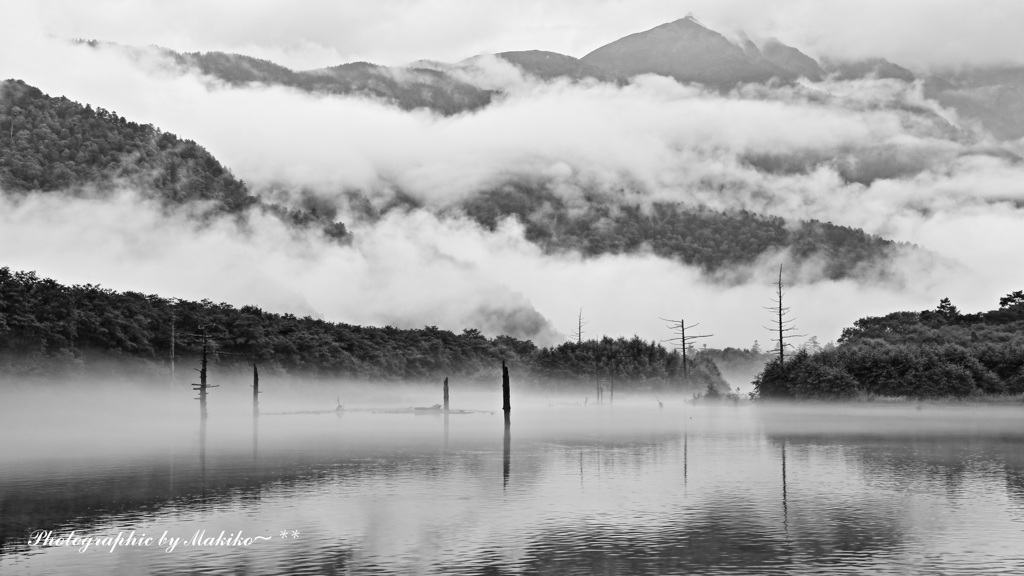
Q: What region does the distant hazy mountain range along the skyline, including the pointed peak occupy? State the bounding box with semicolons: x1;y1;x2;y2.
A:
80;15;1024;139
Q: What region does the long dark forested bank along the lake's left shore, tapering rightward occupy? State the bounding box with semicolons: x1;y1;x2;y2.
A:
0;268;727;389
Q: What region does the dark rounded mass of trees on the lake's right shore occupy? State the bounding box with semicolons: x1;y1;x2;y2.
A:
755;290;1024;399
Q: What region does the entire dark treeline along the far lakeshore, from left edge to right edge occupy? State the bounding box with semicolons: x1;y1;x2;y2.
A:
0;268;1024;400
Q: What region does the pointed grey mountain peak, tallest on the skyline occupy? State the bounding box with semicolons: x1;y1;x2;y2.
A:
581;16;795;89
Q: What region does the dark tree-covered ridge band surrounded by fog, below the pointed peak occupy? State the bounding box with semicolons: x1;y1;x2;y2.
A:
463;184;909;280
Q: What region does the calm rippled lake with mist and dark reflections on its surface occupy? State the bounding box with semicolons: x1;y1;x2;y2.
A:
0;383;1024;575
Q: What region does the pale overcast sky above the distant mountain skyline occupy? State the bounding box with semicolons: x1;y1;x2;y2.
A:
22;0;1024;69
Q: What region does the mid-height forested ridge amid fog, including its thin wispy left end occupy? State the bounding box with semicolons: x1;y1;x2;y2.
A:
329;177;939;285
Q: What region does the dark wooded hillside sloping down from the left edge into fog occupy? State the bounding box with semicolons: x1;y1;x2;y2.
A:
0;80;347;239
